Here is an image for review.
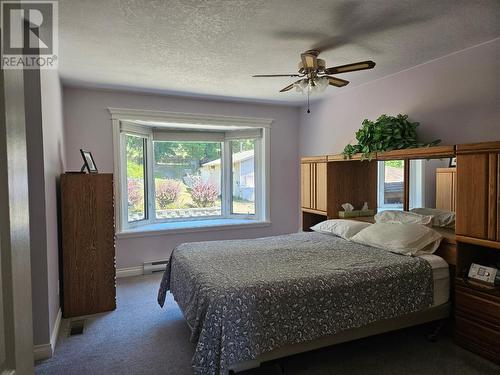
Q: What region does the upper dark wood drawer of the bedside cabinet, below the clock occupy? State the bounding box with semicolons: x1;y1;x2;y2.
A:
455;286;500;326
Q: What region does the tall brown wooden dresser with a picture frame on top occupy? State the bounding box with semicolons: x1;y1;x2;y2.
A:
61;173;116;318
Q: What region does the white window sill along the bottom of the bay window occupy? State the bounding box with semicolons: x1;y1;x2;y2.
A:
116;219;271;239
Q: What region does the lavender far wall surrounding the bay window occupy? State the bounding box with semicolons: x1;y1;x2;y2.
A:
63;87;299;268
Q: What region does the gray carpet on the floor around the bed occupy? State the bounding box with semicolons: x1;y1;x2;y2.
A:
36;274;500;375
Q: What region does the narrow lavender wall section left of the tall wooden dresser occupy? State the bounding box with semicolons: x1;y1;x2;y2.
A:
25;70;64;345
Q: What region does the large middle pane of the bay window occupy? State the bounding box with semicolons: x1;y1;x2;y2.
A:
154;141;222;219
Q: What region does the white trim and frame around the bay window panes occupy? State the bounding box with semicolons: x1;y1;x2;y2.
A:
108;108;274;234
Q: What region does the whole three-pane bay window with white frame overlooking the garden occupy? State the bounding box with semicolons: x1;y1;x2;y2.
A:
110;110;269;232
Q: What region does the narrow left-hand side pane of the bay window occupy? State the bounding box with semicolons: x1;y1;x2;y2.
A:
125;135;146;222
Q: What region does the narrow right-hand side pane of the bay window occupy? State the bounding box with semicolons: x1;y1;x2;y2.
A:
231;139;255;215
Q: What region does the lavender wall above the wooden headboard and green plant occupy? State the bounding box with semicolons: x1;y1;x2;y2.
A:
300;38;500;156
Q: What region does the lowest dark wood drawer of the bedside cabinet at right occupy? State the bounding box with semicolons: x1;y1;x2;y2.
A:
455;312;500;363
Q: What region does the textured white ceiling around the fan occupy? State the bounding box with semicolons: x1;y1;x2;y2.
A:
59;0;500;104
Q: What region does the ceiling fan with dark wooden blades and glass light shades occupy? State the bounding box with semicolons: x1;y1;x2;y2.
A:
253;49;375;113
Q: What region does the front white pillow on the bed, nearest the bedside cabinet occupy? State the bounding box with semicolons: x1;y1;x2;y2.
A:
351;223;442;255
